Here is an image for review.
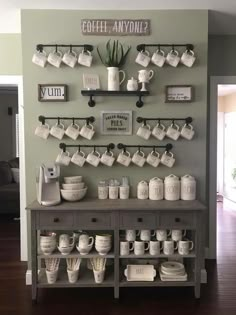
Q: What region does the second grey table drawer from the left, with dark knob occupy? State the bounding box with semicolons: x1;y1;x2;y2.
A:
76;212;113;230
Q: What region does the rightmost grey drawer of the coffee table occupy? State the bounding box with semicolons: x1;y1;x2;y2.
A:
159;213;196;228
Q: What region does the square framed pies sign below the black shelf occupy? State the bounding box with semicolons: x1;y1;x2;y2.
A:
101;111;132;136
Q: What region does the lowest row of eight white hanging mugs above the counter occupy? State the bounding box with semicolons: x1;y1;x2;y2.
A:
56;149;175;167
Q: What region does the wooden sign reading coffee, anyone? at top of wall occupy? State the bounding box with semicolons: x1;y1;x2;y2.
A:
81;19;150;36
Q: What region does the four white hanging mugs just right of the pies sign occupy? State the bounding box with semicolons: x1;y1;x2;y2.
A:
137;122;195;141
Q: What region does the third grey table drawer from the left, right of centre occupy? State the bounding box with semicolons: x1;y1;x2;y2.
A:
120;211;157;229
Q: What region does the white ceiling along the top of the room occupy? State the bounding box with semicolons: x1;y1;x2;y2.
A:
0;0;236;34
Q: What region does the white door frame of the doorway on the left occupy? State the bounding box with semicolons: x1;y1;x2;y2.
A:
0;75;28;261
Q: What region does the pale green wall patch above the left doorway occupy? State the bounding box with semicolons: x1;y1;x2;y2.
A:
0;34;22;75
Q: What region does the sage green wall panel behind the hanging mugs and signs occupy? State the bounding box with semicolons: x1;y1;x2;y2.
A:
22;10;208;202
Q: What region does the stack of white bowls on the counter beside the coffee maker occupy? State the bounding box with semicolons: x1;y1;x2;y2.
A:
61;176;88;201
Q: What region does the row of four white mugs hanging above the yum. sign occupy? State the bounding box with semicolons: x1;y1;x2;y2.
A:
32;49;93;68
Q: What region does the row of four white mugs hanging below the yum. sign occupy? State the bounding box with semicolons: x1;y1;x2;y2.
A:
34;122;95;140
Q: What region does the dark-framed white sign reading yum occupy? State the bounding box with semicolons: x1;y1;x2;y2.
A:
38;84;67;102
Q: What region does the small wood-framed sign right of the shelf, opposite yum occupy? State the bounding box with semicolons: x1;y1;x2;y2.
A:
165;85;193;103
